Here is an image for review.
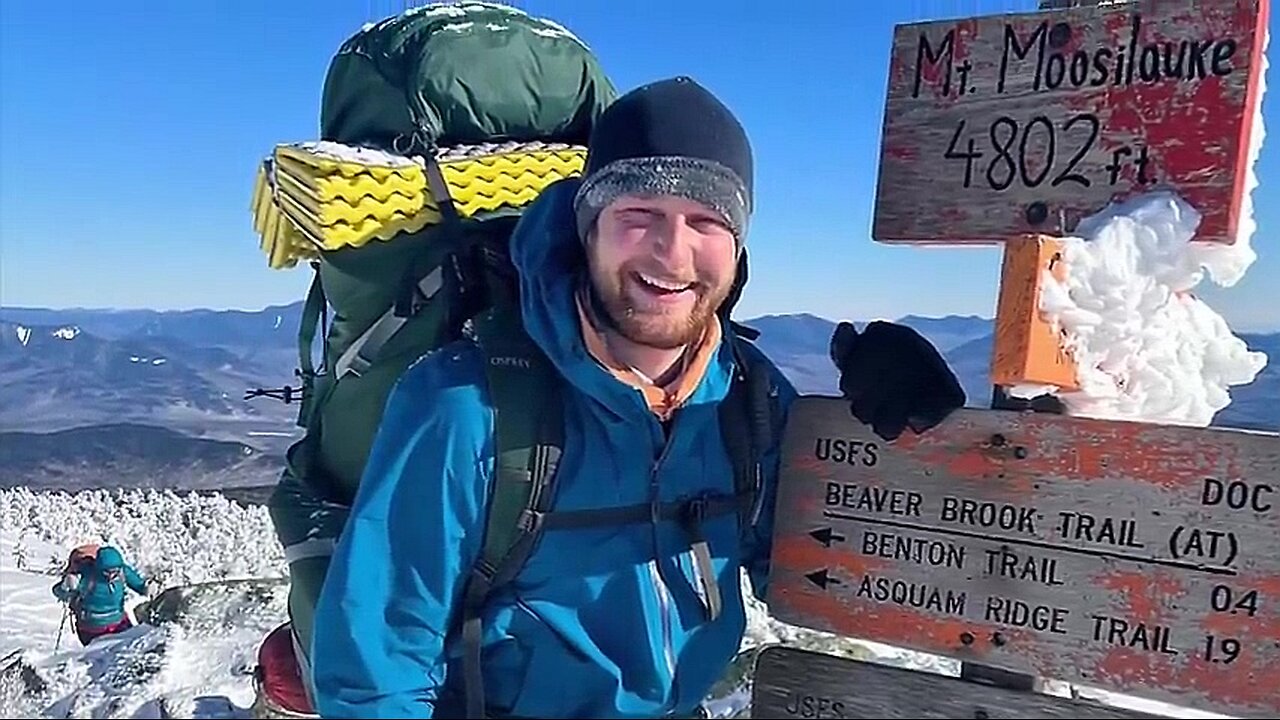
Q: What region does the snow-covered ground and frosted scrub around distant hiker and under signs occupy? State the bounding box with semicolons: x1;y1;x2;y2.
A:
0;488;1216;717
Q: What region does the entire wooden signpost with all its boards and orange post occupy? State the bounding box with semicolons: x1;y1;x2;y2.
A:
754;0;1280;717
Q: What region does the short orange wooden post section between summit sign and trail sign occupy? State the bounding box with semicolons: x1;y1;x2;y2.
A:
991;236;1079;389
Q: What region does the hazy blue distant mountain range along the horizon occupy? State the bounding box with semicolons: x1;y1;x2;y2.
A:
0;302;1280;487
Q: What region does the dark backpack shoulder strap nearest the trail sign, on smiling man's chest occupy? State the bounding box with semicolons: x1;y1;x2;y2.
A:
719;323;780;532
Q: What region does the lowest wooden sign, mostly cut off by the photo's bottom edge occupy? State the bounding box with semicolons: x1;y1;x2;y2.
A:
751;646;1165;719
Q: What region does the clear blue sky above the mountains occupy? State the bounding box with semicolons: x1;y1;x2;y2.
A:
0;0;1280;329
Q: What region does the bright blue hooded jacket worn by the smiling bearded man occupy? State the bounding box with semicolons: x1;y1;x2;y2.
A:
311;179;795;717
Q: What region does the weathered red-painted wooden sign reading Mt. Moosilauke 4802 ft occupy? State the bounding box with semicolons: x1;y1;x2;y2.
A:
872;0;1268;243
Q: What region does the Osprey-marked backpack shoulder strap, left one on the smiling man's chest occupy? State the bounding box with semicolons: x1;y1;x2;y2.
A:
461;306;564;717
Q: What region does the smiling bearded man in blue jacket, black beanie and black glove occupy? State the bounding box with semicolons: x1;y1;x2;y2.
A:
312;78;964;717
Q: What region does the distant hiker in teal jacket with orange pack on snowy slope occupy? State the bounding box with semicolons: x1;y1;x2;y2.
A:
52;544;147;646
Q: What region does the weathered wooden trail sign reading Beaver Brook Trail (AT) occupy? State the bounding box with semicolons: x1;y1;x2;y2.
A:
768;397;1280;717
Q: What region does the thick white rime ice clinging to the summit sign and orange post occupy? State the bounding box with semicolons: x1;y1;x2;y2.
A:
1010;33;1270;427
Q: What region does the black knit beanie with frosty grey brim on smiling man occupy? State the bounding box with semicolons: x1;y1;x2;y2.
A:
573;77;754;249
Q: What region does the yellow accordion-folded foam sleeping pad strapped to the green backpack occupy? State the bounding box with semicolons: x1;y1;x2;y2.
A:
252;142;586;269
